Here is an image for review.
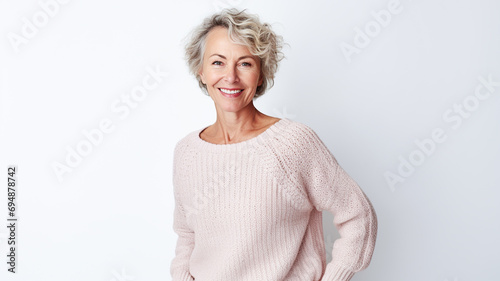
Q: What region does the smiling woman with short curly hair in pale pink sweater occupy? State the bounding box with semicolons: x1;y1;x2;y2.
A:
171;10;377;281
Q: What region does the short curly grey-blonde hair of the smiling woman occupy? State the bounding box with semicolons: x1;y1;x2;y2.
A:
185;8;284;99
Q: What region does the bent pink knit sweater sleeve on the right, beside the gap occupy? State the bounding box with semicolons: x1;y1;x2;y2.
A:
299;126;377;281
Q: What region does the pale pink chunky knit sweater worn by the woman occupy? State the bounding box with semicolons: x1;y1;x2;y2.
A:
170;118;377;281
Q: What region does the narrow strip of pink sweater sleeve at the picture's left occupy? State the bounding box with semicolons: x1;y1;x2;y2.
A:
170;142;194;281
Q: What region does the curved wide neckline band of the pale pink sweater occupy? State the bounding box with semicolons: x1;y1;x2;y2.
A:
194;118;291;152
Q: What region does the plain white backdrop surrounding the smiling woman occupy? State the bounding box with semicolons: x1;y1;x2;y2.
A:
0;0;500;281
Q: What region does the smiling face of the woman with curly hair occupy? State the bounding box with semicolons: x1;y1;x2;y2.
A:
199;27;262;112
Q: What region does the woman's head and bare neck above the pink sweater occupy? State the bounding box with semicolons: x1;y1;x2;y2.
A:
186;9;283;144
